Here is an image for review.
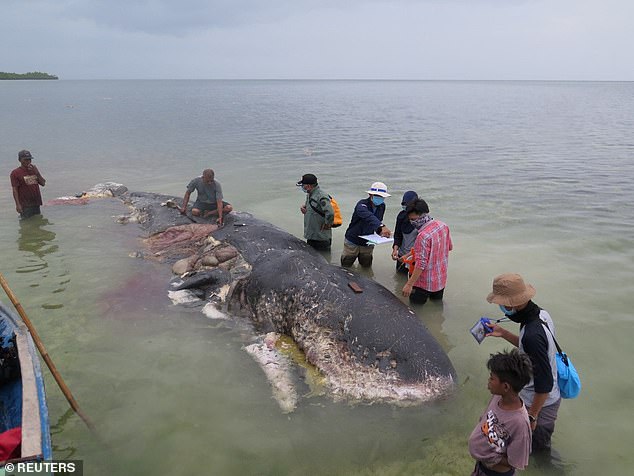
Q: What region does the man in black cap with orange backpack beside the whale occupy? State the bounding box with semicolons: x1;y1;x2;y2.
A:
296;174;335;251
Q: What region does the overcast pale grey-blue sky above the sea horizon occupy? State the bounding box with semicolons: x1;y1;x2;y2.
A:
0;0;634;81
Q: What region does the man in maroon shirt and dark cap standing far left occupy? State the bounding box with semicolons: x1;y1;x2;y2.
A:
11;150;46;218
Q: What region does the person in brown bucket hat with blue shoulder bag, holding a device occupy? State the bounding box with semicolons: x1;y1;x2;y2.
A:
487;273;561;463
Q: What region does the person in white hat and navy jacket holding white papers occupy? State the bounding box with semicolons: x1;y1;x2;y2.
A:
341;182;392;268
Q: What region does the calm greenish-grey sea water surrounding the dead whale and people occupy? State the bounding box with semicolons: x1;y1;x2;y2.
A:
0;81;634;475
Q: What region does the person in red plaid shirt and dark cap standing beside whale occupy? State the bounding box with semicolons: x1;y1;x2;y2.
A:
403;199;453;304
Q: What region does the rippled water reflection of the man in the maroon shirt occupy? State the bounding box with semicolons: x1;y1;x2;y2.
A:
16;215;59;277
